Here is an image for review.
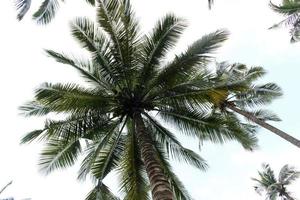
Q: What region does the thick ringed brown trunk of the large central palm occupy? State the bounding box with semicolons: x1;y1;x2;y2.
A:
133;113;174;200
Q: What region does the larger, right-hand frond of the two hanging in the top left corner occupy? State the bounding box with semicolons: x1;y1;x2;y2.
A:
33;0;59;24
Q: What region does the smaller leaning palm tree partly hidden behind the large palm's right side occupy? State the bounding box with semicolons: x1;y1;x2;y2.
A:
213;62;300;148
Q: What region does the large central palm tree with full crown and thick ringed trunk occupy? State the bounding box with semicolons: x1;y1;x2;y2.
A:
21;0;257;200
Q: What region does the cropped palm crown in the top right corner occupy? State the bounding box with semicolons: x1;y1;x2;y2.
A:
270;0;300;43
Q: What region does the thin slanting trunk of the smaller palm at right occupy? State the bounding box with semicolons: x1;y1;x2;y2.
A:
226;104;300;148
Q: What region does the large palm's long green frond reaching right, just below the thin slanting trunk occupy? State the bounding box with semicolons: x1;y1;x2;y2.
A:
159;107;257;150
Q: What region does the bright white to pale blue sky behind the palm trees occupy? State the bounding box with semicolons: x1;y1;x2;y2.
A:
0;0;300;200
